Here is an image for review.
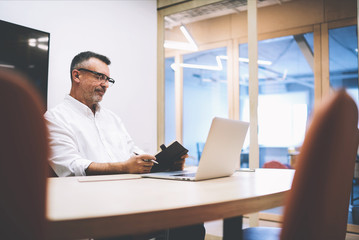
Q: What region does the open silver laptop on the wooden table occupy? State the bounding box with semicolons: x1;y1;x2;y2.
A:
142;117;249;181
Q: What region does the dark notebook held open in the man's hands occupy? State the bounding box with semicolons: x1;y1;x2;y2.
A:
151;141;188;172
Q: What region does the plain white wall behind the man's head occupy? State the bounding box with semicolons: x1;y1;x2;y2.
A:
0;0;157;153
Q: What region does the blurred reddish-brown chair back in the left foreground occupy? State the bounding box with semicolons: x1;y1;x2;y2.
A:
0;69;49;240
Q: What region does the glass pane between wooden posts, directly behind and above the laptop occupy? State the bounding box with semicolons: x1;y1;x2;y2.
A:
182;48;228;165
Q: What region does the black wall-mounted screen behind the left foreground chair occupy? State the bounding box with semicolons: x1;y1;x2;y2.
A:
0;20;50;109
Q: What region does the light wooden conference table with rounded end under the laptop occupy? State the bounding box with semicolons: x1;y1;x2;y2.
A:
47;169;294;239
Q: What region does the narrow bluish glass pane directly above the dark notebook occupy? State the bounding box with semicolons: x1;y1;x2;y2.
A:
165;57;176;146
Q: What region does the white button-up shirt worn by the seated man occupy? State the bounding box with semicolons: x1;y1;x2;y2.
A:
45;95;143;177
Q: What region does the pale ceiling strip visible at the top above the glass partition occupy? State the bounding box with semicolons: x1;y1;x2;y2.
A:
165;0;292;29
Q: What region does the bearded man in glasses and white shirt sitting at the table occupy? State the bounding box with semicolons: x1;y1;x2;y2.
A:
45;52;204;239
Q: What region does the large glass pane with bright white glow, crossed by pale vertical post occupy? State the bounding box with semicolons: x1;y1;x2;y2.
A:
239;33;314;167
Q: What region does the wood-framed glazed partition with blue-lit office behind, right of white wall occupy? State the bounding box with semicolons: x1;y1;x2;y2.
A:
158;0;359;233
